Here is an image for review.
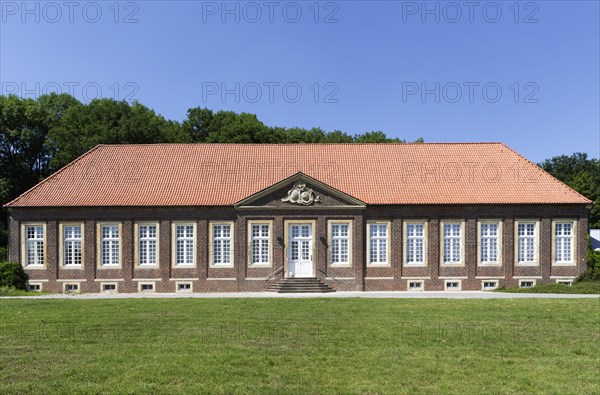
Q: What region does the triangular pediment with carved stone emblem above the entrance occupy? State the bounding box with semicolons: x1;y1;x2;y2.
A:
234;173;366;209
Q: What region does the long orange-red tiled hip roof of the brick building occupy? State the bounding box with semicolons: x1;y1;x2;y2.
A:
6;143;591;207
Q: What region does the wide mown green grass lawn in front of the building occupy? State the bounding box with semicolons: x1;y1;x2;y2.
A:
0;298;600;395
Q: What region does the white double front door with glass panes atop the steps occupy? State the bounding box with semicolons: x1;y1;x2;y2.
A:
288;224;315;277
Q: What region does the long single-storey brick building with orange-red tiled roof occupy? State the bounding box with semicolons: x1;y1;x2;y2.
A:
5;143;592;292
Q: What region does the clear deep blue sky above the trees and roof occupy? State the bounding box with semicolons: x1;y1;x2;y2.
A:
0;0;600;162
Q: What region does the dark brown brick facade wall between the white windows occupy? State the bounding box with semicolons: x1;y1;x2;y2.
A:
9;204;588;292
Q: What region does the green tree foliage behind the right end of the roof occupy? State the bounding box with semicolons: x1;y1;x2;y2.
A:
539;152;600;229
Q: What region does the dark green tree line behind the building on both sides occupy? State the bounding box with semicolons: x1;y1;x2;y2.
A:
0;93;600;261
